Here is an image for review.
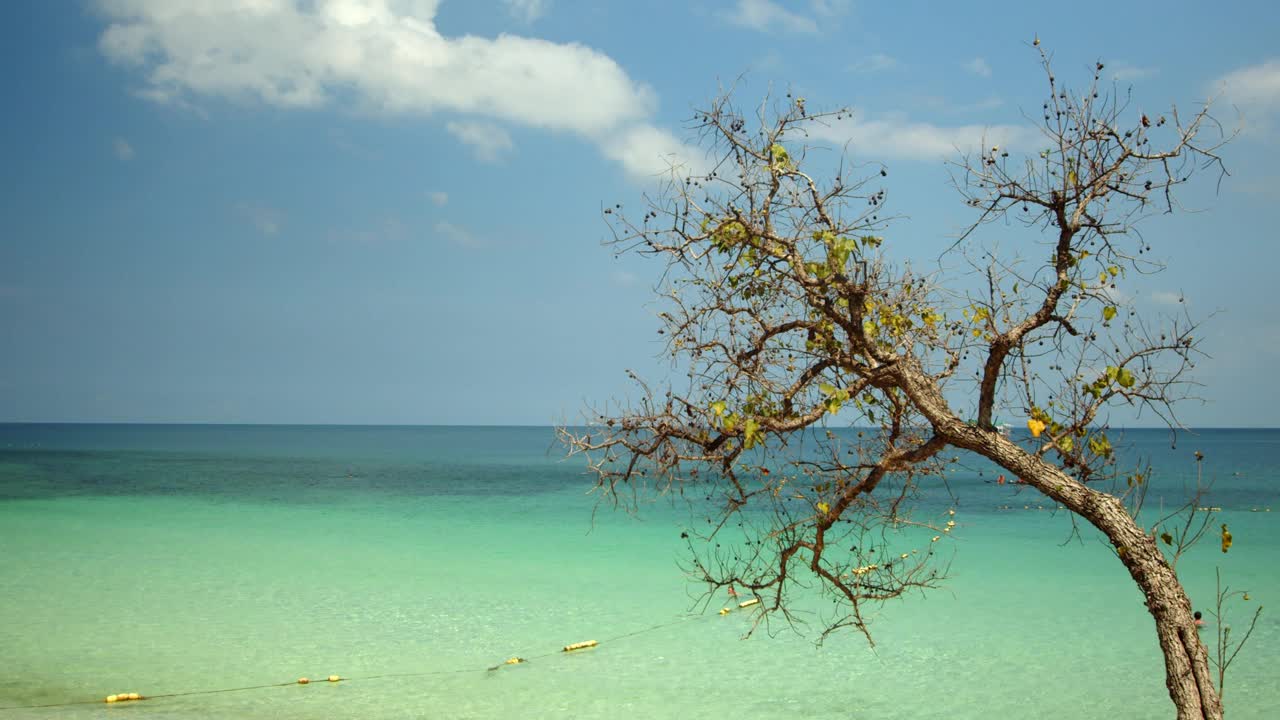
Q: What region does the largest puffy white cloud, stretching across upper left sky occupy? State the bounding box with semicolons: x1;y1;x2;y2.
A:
96;0;680;178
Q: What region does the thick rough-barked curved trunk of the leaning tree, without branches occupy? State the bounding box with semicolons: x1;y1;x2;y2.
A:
904;372;1222;720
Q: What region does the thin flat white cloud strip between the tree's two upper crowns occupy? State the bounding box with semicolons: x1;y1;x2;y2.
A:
809;111;1041;160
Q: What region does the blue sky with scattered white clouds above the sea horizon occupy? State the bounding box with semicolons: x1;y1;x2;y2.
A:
0;0;1280;427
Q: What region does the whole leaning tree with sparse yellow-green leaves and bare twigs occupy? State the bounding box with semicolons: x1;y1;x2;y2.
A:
561;51;1228;719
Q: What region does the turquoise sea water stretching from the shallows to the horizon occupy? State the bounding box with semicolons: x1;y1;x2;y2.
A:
0;425;1280;719
